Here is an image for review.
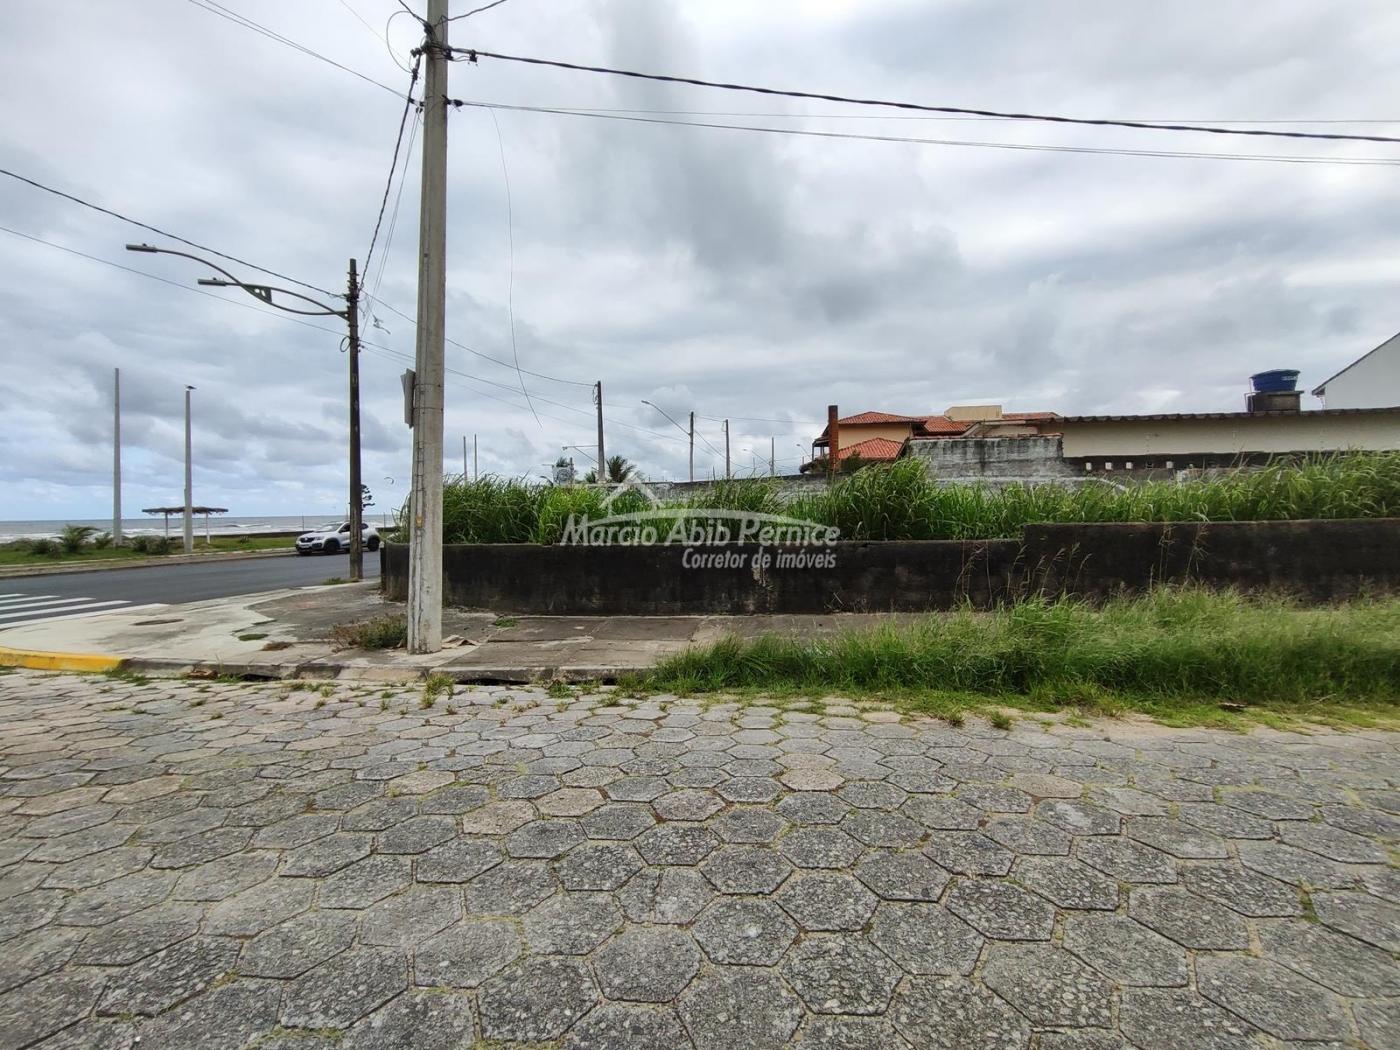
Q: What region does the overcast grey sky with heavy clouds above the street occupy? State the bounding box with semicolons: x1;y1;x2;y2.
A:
0;0;1400;518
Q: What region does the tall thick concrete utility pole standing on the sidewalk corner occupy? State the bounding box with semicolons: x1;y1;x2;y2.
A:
409;0;448;652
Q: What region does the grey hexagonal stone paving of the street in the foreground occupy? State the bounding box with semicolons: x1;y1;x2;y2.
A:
0;672;1400;1050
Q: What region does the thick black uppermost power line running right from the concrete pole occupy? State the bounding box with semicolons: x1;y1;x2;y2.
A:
451;48;1400;143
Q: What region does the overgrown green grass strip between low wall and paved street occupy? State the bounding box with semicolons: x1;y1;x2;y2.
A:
622;588;1400;725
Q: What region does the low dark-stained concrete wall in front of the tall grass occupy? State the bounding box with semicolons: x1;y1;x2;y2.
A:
381;518;1400;615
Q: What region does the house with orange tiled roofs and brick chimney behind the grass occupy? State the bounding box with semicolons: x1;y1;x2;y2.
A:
806;405;1058;469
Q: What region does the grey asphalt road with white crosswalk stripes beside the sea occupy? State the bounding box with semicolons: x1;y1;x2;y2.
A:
0;552;379;616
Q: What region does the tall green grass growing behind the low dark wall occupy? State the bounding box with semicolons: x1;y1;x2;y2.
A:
422;452;1400;543
